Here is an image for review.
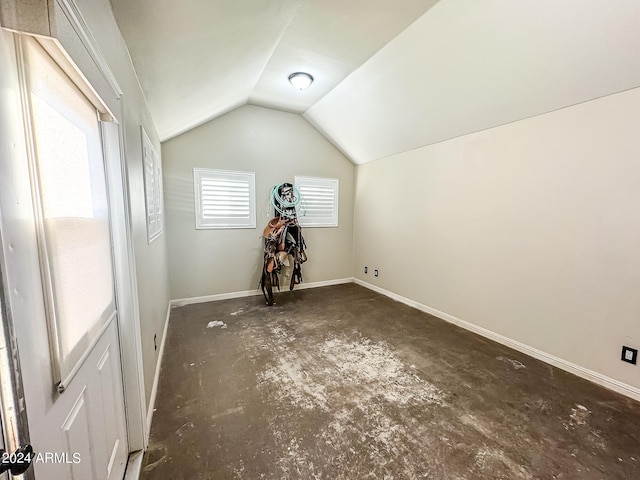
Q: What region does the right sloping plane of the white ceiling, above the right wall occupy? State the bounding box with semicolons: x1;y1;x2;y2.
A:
305;0;640;163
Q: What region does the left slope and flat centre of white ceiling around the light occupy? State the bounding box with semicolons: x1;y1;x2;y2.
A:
111;0;437;141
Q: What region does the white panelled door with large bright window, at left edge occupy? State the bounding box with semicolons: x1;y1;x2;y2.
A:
0;33;128;480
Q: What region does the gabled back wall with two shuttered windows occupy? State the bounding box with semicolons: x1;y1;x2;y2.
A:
162;105;355;299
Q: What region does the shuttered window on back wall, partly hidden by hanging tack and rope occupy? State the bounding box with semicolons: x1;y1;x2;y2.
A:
294;177;338;227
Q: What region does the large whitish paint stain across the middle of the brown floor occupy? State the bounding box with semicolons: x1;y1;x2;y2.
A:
258;330;446;478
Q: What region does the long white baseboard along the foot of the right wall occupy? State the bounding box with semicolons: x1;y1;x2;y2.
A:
353;278;640;401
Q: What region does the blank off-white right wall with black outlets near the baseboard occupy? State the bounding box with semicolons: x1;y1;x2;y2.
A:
355;89;640;391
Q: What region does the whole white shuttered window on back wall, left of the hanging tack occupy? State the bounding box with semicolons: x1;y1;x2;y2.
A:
193;168;256;229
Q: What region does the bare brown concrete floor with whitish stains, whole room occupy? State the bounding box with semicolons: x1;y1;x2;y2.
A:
141;284;640;480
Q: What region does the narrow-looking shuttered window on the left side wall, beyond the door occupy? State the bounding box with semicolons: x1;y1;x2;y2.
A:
140;127;163;243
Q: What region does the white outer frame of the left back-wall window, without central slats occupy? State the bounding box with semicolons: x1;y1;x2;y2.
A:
193;167;256;230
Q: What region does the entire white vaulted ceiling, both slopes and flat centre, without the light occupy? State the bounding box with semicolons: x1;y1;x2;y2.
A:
111;0;640;163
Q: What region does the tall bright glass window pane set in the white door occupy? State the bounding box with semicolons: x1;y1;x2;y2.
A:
21;37;116;385
